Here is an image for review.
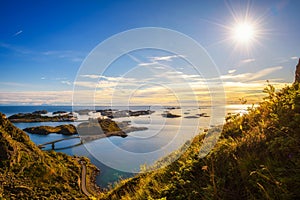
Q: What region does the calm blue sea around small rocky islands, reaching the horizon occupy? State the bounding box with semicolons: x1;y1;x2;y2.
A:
0;105;251;188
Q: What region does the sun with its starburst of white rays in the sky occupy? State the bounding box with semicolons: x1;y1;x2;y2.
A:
201;0;274;65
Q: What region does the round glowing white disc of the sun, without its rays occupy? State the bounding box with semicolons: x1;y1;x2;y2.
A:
231;22;257;45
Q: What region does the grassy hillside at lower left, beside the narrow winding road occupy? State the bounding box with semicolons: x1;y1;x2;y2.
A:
0;113;99;199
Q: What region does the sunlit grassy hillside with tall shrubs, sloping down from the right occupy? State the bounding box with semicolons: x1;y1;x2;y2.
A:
102;83;300;200
